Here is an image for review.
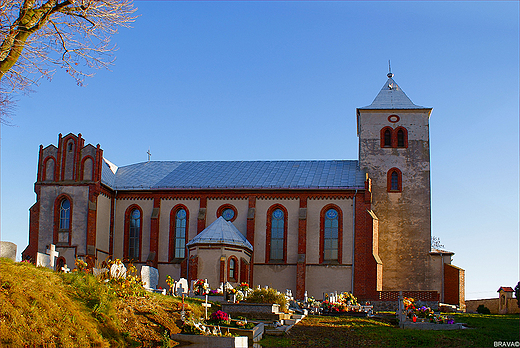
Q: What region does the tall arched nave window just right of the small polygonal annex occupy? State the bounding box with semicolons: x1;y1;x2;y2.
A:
266;205;287;263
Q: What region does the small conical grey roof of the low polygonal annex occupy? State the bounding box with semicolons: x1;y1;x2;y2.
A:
186;216;253;251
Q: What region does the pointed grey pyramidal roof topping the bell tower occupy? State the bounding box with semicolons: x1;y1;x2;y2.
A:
358;74;431;110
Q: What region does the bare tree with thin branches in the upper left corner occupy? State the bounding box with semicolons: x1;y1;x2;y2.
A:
0;0;136;123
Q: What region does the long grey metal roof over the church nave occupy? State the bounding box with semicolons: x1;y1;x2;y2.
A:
101;160;365;190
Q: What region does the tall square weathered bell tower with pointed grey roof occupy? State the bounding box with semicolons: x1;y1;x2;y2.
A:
356;72;433;290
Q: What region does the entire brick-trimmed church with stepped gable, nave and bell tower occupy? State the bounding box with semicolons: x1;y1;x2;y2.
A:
23;73;464;305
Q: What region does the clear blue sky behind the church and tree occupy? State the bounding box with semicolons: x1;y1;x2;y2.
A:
1;1;520;299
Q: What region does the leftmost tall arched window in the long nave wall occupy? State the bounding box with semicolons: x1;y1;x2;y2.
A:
123;204;143;261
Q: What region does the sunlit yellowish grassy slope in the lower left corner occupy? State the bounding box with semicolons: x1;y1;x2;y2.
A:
0;259;207;347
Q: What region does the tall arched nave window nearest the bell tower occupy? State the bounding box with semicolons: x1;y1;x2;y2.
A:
320;204;343;263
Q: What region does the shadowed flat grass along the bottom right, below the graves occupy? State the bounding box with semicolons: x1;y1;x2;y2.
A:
260;314;520;347
